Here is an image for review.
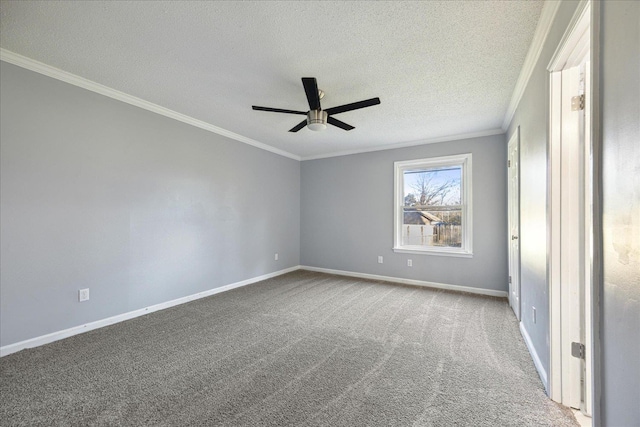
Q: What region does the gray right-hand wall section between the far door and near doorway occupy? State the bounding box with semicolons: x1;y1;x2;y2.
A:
507;2;578;382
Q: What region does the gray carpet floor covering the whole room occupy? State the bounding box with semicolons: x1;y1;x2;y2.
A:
0;271;577;426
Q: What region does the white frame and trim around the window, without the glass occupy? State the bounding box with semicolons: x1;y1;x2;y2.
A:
393;153;473;258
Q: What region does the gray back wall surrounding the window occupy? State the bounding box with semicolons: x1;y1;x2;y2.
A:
300;135;508;291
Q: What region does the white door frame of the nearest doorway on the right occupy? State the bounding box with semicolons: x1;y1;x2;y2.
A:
547;0;602;425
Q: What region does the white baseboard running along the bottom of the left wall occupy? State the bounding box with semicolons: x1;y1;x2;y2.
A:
0;265;300;357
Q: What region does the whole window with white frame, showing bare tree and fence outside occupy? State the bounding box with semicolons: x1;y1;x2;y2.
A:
393;154;473;257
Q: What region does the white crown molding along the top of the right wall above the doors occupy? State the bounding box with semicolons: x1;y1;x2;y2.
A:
502;0;561;131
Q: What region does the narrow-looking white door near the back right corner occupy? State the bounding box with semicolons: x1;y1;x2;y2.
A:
507;126;520;320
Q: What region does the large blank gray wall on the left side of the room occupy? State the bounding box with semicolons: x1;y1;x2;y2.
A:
0;62;300;352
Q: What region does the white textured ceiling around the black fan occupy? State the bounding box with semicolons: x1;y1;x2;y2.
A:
0;0;543;158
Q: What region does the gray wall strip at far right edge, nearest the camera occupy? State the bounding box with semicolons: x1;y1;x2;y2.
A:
600;1;640;426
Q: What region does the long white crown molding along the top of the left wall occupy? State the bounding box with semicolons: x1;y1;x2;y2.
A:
0;48;301;161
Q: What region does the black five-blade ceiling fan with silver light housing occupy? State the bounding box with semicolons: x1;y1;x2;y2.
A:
252;77;380;132
